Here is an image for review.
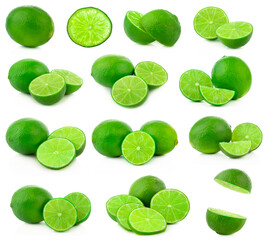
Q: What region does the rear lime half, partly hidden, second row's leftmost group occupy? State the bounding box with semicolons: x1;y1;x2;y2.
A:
51;69;83;94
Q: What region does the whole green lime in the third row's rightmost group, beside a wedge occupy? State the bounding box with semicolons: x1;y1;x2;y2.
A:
189;116;232;154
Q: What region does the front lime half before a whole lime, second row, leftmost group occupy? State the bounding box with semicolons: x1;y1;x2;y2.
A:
29;73;66;105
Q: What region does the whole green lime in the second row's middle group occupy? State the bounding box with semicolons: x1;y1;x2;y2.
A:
91;55;134;87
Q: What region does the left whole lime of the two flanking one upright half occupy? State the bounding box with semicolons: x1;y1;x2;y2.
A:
92;120;132;157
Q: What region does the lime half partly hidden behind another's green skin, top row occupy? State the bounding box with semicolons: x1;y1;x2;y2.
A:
124;11;154;45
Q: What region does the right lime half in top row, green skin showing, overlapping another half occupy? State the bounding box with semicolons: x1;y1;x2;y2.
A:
140;9;181;47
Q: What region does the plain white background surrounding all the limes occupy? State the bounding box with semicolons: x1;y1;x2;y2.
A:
0;0;266;240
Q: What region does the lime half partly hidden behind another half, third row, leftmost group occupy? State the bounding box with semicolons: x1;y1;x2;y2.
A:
48;127;86;156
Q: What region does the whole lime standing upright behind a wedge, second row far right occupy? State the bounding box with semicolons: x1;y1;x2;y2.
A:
212;56;252;99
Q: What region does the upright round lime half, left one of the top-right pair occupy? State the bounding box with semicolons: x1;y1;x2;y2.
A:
193;7;229;39
